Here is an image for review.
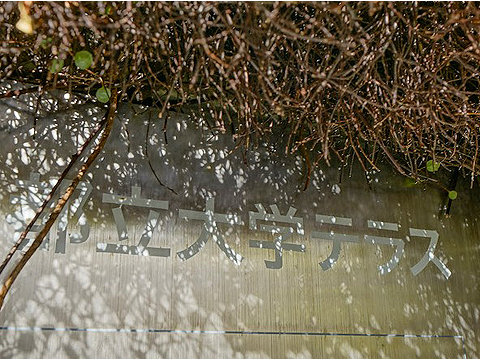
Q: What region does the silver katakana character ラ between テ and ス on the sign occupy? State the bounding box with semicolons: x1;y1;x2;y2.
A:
364;220;405;275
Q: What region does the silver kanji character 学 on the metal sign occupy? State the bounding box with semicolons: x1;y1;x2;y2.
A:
249;204;305;269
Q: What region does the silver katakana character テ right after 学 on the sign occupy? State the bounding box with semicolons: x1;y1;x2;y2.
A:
311;214;360;271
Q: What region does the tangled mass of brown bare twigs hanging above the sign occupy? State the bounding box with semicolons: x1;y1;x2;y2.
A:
0;2;480;185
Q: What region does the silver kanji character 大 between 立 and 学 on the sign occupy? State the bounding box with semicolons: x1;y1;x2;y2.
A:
177;198;243;265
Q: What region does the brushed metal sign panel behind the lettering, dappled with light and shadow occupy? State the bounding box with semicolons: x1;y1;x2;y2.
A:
0;85;480;357
